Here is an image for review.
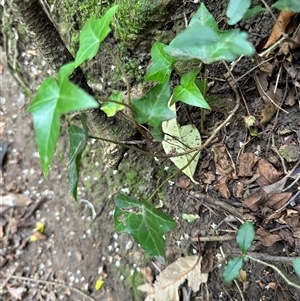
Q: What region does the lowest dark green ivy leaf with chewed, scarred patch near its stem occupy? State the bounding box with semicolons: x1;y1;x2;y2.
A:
114;194;177;257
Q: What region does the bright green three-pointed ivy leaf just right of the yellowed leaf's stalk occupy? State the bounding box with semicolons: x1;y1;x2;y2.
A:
171;68;210;109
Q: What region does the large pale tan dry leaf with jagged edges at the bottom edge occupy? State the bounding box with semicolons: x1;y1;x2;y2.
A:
138;256;208;301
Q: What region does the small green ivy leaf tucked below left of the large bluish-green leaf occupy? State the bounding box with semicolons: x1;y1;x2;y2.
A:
146;42;176;84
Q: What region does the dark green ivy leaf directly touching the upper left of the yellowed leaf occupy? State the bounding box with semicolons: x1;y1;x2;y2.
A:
131;81;176;127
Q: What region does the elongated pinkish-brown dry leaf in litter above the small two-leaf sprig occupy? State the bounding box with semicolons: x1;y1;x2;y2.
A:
244;176;288;211
